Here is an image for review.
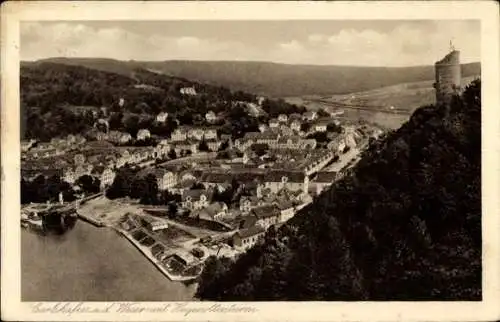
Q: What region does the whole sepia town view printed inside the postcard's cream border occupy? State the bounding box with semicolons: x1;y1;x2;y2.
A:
2;1;498;318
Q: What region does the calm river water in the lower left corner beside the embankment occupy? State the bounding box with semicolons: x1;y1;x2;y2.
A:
21;220;196;301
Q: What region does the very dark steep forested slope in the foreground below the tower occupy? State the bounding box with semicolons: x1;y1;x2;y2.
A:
197;80;482;301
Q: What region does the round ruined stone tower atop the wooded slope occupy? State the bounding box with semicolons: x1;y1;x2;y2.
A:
434;46;462;105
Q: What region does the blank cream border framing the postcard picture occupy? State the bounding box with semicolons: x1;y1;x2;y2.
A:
1;1;500;321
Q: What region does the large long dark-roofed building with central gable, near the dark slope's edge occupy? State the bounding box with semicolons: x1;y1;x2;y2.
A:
263;171;309;193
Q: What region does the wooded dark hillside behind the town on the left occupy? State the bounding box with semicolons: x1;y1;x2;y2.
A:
21;62;303;141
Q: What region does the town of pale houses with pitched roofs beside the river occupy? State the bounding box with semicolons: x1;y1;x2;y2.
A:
21;92;383;281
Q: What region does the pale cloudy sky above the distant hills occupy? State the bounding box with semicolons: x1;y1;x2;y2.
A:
20;20;481;66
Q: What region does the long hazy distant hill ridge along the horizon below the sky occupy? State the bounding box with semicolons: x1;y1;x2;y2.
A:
28;58;481;97
